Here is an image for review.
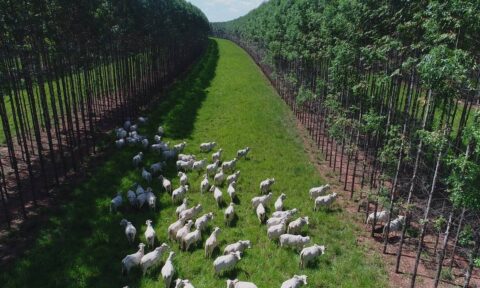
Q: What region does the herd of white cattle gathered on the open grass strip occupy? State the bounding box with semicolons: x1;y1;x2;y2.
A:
110;117;337;288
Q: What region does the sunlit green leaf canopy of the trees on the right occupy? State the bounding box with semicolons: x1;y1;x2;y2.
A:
213;0;480;280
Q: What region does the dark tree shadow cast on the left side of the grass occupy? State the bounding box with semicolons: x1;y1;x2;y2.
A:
0;40;219;287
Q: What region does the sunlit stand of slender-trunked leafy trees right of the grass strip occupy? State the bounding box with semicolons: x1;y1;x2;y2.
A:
212;0;480;287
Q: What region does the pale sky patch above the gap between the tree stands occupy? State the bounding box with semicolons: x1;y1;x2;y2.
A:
187;0;265;22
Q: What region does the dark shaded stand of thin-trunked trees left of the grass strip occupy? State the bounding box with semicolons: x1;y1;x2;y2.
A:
0;0;210;226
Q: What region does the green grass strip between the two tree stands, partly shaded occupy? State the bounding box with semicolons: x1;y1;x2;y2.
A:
0;40;387;288
